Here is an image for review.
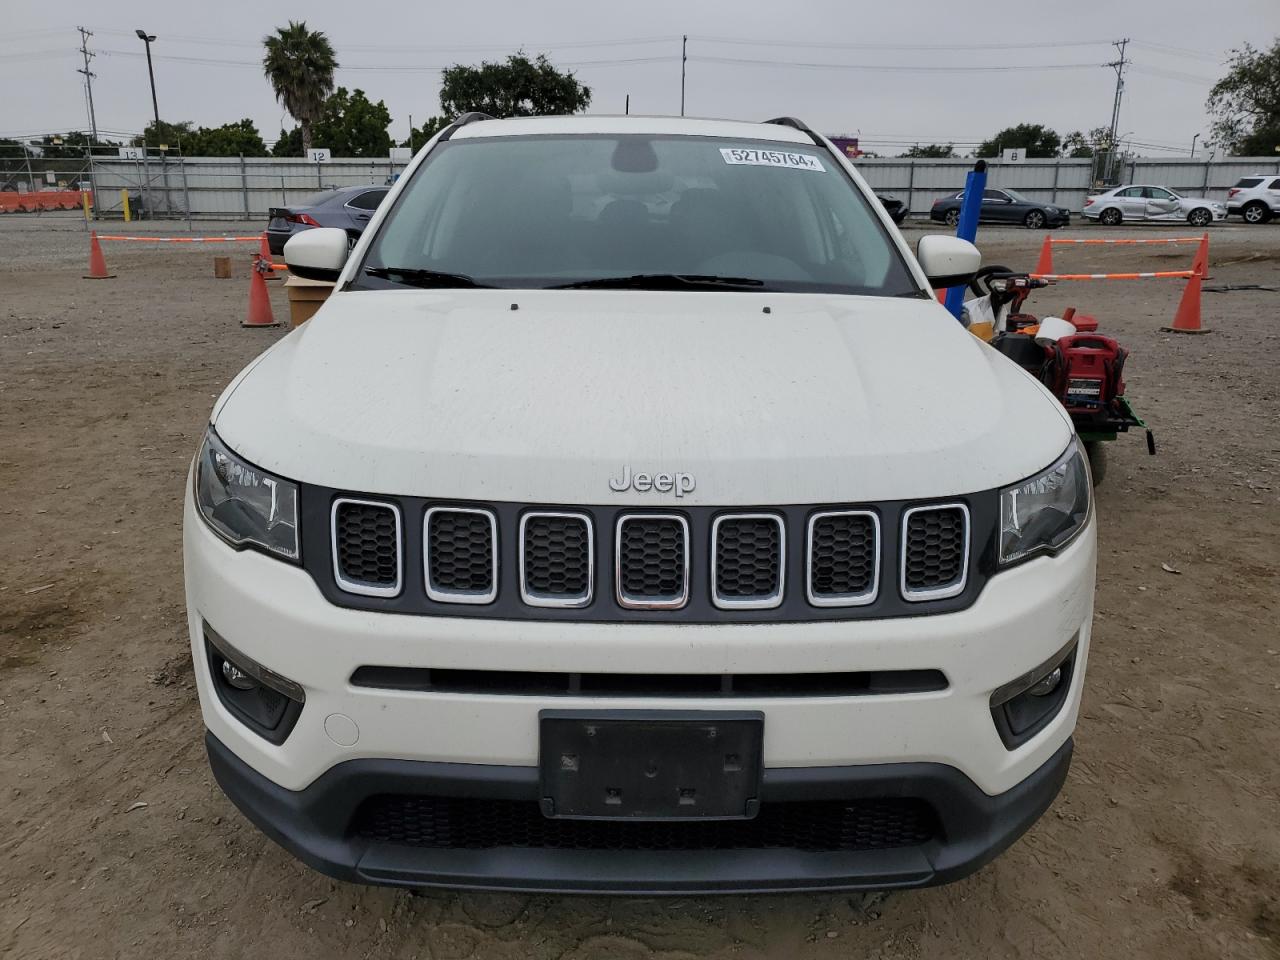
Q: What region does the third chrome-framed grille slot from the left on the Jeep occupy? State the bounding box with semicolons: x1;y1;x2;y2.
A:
520;512;595;607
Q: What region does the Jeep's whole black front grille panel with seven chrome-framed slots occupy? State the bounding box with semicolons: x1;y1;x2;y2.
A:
314;486;972;623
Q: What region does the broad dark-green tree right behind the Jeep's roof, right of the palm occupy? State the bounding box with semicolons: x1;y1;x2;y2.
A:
440;51;591;116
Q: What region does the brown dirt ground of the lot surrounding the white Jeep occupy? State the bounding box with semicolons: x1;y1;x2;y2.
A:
0;218;1280;960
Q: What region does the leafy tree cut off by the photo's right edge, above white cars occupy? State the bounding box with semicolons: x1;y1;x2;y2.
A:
1204;40;1280;156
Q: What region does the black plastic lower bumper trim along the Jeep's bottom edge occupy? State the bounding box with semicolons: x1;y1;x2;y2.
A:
205;733;1071;895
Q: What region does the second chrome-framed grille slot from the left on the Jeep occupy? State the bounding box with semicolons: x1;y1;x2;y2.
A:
422;507;498;603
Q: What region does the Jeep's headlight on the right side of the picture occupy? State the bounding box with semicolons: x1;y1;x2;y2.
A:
1000;440;1092;566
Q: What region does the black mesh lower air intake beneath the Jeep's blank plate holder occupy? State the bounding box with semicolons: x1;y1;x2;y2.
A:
353;796;938;851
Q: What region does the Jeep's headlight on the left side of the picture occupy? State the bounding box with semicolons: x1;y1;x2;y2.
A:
196;428;298;561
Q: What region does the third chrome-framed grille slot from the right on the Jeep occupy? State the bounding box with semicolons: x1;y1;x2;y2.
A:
712;513;786;609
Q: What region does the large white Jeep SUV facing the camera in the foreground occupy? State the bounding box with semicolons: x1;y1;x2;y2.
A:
184;115;1096;893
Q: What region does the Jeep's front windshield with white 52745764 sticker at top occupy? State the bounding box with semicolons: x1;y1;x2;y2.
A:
356;134;919;296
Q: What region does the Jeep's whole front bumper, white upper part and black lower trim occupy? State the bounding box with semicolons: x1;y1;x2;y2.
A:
183;493;1097;892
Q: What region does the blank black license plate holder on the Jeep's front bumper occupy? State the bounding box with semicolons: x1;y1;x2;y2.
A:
539;710;764;820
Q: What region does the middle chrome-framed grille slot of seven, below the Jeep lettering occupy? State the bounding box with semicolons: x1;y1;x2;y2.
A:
614;513;689;609
